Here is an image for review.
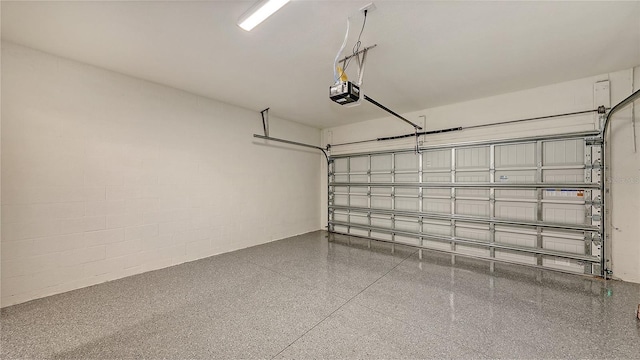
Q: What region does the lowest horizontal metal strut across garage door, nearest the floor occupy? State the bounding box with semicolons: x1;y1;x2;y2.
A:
329;220;600;263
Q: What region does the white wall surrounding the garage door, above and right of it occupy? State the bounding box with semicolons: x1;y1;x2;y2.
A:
321;67;640;282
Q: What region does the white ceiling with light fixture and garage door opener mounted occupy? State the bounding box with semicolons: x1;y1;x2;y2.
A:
2;0;640;128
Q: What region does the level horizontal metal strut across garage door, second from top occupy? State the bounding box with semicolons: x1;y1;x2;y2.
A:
329;182;600;190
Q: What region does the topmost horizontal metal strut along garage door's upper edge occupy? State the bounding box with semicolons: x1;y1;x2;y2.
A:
331;131;601;159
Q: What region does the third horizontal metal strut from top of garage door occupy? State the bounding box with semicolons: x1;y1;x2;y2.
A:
329;205;599;231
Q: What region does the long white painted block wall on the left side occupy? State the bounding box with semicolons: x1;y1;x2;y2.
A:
1;42;322;306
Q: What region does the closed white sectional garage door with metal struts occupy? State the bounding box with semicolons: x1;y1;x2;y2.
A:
329;133;604;275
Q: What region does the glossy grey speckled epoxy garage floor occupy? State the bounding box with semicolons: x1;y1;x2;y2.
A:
0;232;640;359
